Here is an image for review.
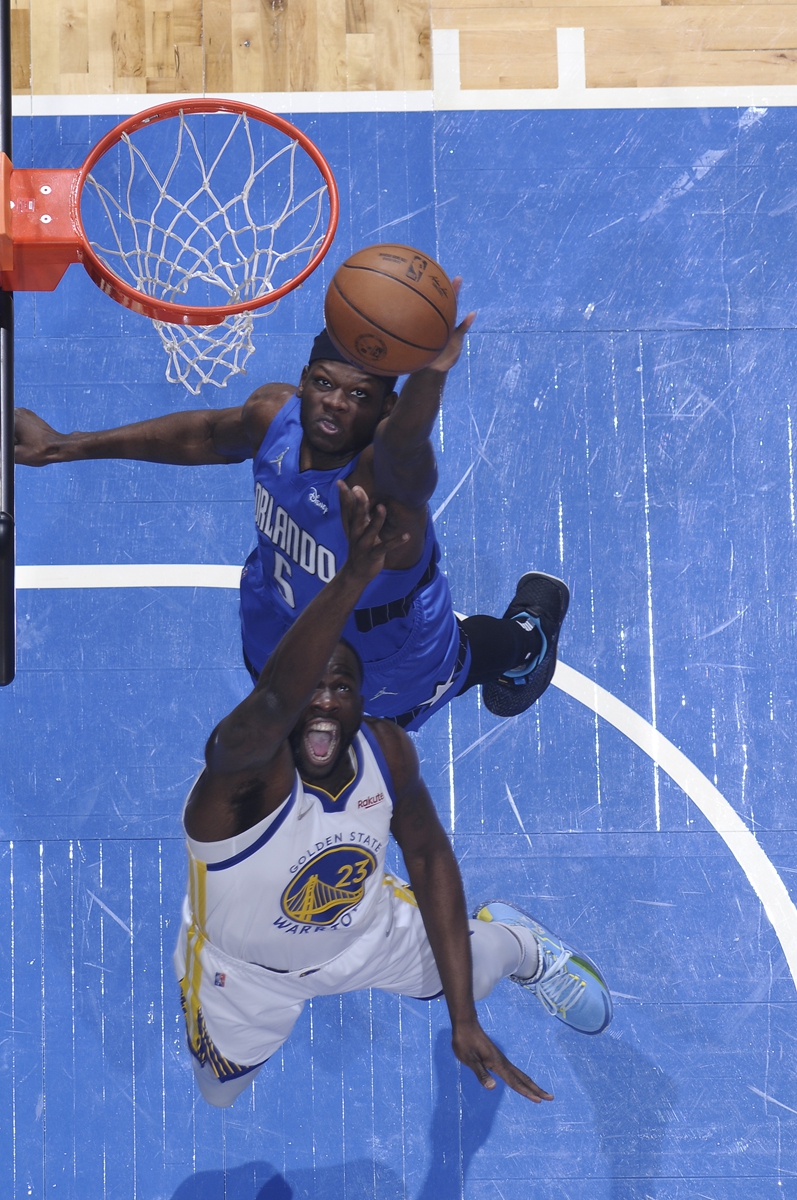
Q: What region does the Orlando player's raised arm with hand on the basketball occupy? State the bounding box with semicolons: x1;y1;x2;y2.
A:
373;283;477;509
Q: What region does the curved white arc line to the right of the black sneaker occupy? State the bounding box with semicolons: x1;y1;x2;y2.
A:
552;661;797;985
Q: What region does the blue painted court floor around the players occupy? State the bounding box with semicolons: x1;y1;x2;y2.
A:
0;109;797;1200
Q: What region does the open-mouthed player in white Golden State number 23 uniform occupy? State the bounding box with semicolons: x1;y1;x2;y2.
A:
174;482;611;1108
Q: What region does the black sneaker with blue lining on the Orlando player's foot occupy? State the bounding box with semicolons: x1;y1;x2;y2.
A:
481;571;570;716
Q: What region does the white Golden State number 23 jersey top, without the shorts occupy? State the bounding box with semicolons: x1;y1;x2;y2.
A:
177;724;394;971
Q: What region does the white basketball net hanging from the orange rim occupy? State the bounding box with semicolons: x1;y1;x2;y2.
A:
83;113;326;396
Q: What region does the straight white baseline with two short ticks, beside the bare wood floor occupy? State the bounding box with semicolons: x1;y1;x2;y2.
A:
12;28;797;116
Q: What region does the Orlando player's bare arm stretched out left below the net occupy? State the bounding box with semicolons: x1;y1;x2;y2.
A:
14;384;294;467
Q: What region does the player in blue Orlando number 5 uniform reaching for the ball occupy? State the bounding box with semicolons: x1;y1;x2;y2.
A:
17;289;569;730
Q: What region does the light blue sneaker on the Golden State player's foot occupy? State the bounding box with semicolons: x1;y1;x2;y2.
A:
473;900;612;1034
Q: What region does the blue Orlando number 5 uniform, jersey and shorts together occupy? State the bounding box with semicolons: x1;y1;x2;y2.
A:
236;396;468;730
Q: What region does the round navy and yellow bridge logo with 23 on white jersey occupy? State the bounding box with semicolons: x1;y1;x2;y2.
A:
281;846;377;925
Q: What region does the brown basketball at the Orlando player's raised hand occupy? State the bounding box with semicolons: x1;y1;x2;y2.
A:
324;245;456;376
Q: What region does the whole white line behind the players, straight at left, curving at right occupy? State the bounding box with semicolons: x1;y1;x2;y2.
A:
17;563;797;985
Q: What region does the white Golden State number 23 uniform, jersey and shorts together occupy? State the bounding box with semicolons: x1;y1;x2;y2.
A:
174;722;451;1080
